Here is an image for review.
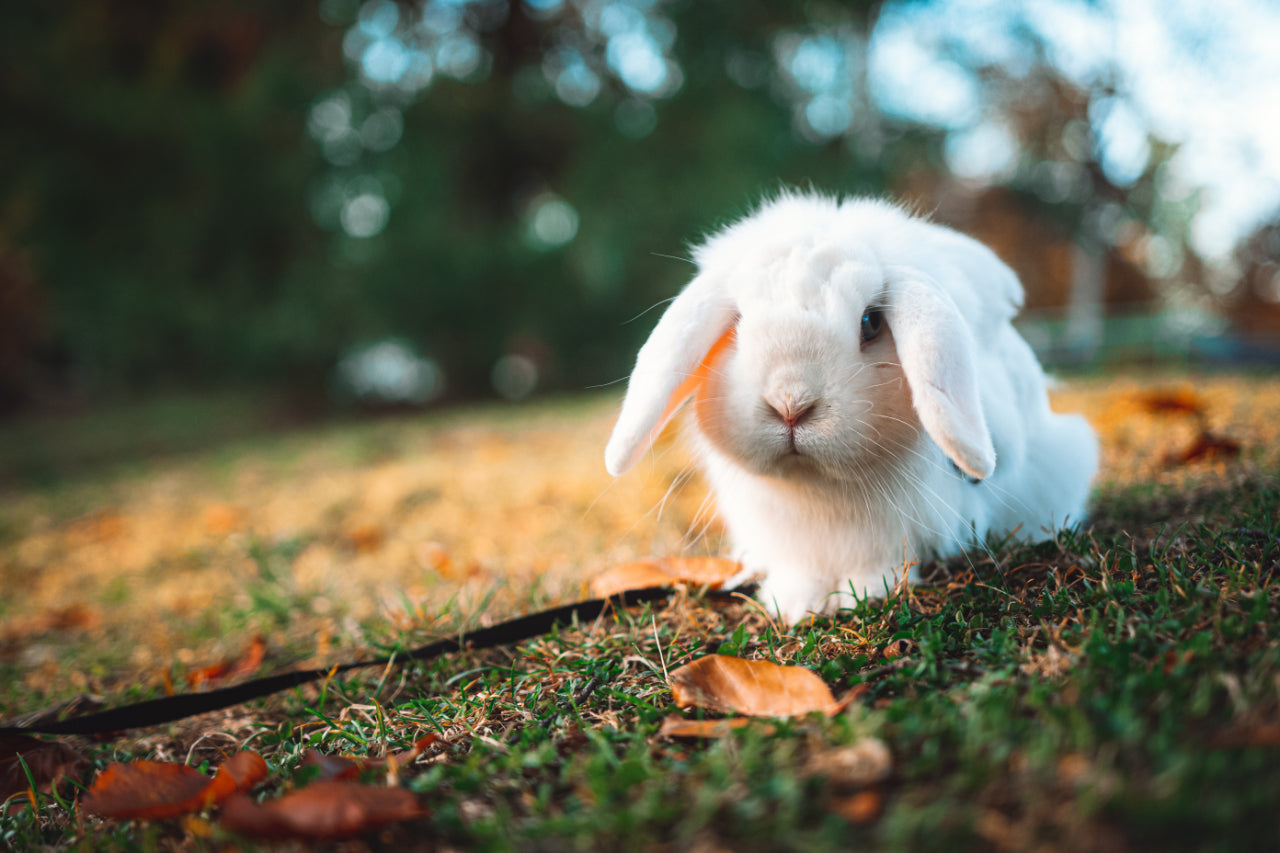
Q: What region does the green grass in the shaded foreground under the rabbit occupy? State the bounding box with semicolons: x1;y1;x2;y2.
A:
0;376;1280;850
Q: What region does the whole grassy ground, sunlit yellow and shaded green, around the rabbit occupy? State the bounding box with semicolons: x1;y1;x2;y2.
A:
0;374;1280;849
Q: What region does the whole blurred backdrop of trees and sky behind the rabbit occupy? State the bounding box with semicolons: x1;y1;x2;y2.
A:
0;0;1280;458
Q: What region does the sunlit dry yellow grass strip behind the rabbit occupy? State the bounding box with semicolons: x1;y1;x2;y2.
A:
0;377;1280;691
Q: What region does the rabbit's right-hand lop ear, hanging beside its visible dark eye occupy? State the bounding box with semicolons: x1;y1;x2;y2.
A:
887;274;996;479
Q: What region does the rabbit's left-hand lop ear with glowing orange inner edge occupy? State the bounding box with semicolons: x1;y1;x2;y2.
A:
604;275;737;476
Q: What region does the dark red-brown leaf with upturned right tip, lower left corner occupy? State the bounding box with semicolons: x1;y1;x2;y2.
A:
81;752;266;820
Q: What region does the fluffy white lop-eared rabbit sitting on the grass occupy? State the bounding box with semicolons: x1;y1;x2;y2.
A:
604;195;1098;622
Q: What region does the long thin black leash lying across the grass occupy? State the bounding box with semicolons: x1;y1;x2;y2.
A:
0;587;750;735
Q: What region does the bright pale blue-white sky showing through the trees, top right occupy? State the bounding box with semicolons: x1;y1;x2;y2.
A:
868;0;1280;259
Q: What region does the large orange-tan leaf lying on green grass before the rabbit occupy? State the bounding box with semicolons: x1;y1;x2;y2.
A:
669;654;852;717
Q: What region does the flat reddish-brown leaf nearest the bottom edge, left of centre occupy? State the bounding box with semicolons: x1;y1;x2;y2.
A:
219;780;426;841
